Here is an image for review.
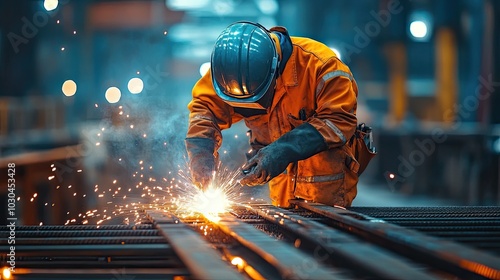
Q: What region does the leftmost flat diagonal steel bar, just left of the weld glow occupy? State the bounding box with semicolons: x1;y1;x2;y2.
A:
147;211;244;280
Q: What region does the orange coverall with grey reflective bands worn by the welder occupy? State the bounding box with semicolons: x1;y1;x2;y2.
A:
187;27;359;207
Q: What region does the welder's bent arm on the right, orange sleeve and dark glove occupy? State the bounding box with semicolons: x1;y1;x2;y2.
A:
240;58;357;186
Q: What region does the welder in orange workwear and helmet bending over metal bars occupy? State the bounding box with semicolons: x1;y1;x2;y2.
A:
185;21;366;208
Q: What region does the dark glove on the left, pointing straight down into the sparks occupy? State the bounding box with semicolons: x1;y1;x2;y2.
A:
185;138;215;189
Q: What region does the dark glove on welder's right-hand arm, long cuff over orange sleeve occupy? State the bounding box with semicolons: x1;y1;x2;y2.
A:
240;123;327;186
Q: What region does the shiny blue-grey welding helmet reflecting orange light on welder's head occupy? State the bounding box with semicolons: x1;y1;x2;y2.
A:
210;21;279;109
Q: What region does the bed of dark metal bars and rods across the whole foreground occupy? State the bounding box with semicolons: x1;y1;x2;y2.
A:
0;201;500;279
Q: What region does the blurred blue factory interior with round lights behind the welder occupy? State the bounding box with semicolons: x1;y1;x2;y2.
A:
0;0;500;224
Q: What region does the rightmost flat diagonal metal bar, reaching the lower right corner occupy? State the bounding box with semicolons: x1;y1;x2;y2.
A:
293;200;500;279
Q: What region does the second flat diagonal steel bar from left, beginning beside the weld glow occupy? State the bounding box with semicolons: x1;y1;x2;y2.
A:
217;215;346;279
